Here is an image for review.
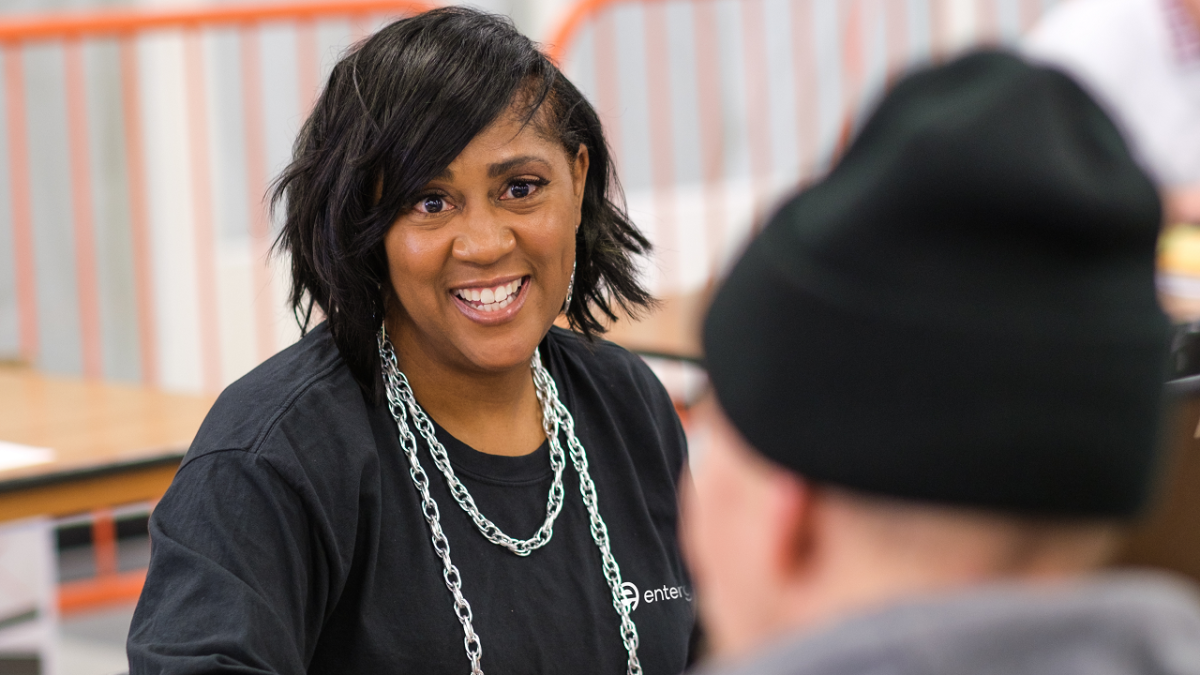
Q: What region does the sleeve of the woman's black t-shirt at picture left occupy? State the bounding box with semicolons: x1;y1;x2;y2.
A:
127;450;329;675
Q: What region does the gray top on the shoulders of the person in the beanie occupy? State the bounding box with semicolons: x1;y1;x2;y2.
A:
694;573;1200;675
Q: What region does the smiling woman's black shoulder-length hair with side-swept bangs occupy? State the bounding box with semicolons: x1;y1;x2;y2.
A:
271;7;654;401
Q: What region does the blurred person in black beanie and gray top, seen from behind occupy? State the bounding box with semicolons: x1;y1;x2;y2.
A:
683;52;1200;675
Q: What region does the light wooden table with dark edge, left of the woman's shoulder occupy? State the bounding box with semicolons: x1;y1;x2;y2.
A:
0;366;215;521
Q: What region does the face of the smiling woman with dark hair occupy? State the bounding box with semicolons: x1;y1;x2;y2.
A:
384;107;588;372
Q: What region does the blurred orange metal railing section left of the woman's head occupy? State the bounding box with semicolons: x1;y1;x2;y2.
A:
0;0;430;390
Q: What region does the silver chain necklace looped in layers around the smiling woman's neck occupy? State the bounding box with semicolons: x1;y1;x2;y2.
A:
377;327;642;675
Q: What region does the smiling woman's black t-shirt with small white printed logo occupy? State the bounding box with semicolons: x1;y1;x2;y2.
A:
128;324;694;675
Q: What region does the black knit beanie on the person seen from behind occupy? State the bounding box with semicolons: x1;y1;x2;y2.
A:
704;53;1168;518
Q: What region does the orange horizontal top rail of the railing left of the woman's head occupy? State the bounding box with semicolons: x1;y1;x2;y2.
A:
0;0;433;41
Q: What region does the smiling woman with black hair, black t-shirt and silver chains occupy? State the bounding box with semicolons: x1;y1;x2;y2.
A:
128;8;694;675
